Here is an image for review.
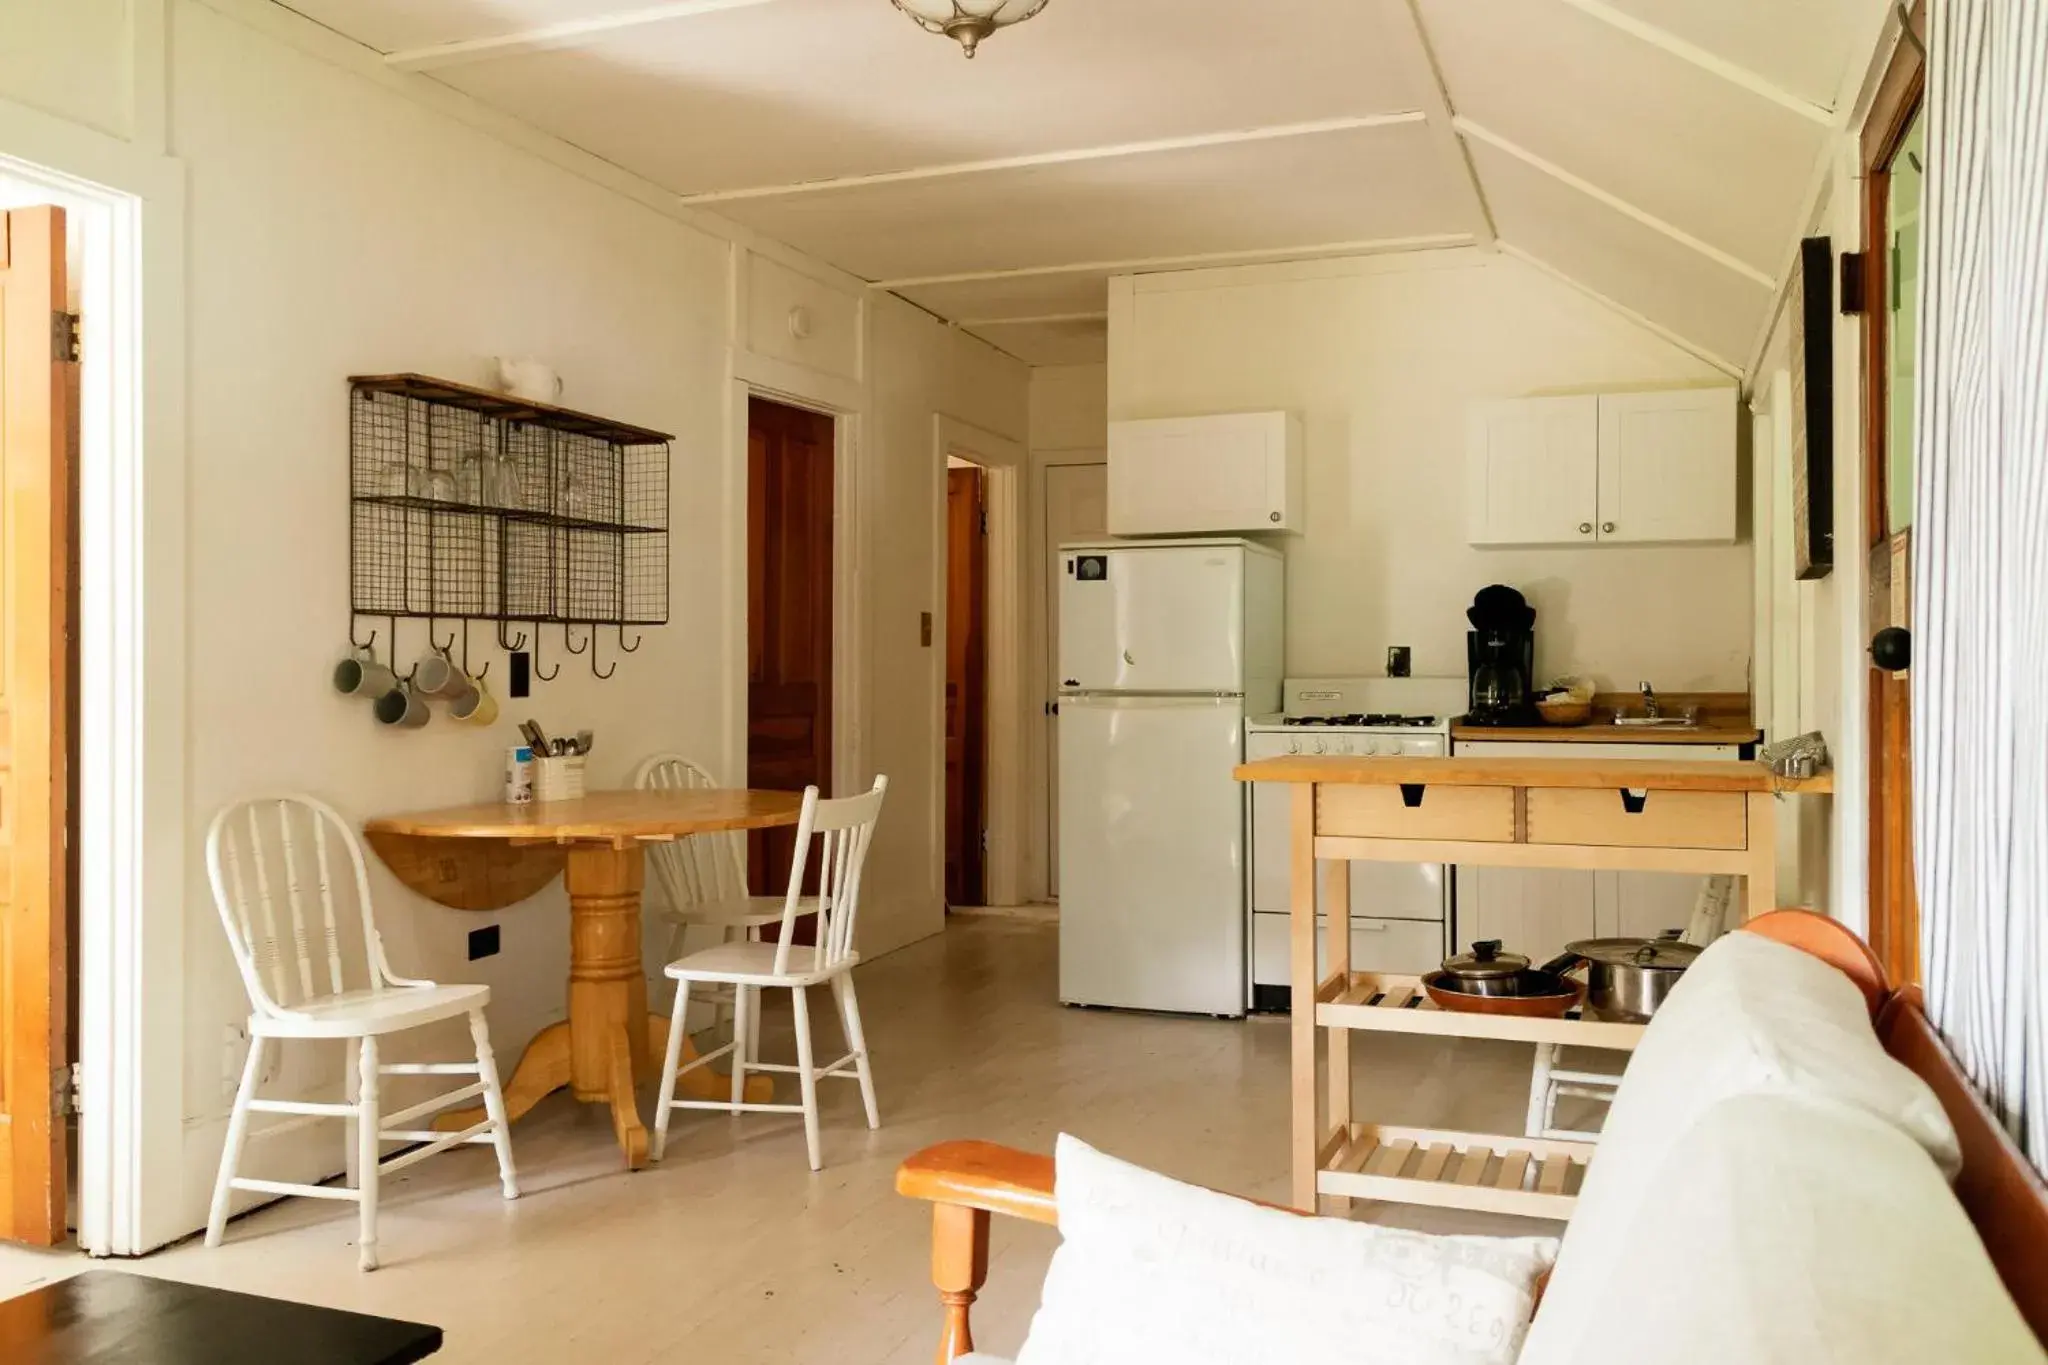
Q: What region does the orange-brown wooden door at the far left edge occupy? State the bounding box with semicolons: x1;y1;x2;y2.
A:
0;209;78;1246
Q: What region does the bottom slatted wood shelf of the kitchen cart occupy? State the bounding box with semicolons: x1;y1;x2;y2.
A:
1315;1124;1593;1220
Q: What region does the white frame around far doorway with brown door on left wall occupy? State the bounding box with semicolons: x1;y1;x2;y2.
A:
930;413;1030;905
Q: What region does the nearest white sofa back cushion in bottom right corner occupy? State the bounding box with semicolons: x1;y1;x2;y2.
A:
1520;1093;2044;1365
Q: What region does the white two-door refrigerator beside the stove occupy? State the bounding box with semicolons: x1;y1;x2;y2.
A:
1059;540;1284;1017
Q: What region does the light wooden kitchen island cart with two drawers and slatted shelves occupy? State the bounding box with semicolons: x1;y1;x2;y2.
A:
1237;757;1831;1218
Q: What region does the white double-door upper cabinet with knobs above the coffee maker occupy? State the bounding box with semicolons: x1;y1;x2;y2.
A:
1466;389;1737;544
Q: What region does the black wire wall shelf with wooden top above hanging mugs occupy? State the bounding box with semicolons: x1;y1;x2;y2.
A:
348;375;674;677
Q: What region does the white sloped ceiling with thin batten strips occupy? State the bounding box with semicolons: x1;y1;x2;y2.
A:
281;0;1888;370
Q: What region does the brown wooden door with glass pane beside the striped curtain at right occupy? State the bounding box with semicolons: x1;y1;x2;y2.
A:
1862;10;1927;984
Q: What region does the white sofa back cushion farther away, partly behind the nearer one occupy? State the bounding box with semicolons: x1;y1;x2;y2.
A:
1532;933;1962;1345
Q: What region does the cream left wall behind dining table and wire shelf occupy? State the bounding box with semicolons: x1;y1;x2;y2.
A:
0;0;1026;1248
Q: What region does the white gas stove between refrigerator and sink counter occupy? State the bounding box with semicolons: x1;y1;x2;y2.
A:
1245;677;1466;1009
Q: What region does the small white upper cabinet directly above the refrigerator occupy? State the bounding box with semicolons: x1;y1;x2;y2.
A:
1110;411;1307;536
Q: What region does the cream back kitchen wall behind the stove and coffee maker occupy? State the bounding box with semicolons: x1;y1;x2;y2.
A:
1110;250;1751;692
